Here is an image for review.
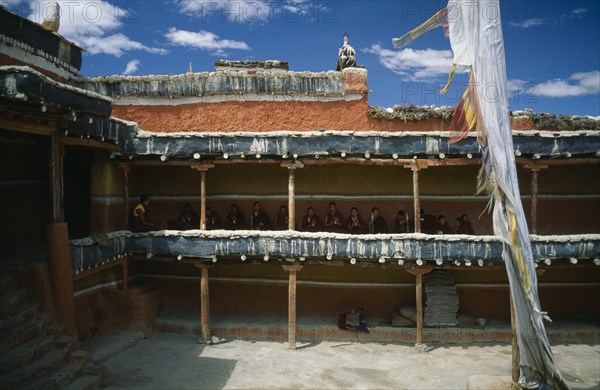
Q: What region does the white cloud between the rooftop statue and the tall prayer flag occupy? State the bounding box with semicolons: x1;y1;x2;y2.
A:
363;44;459;81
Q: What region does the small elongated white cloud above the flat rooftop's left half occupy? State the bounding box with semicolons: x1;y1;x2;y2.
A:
165;27;250;55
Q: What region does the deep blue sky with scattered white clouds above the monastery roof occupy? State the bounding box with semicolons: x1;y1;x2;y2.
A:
5;0;600;116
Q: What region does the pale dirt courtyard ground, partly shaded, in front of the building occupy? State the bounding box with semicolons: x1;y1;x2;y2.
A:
96;333;600;389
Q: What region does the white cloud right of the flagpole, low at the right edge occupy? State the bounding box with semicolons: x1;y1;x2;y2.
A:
508;70;600;98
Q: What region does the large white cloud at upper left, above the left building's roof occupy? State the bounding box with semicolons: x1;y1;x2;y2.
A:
24;0;167;57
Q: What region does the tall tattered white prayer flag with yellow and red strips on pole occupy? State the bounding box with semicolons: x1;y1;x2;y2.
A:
394;0;568;389
